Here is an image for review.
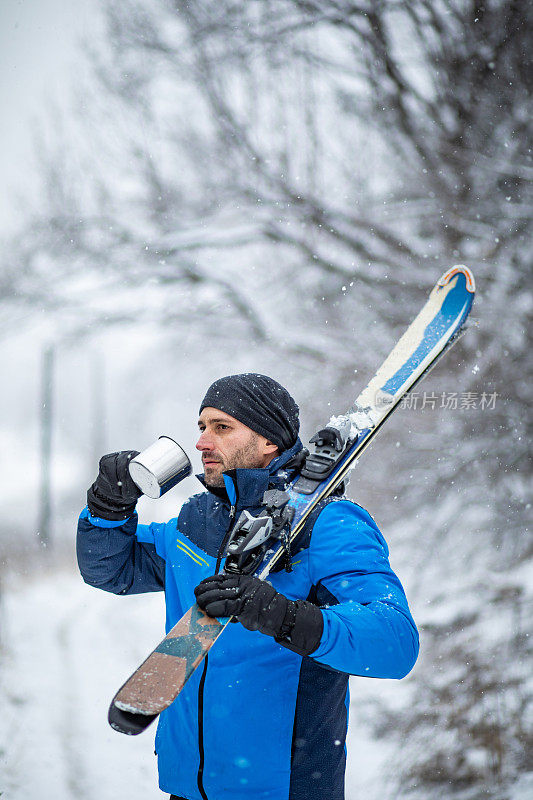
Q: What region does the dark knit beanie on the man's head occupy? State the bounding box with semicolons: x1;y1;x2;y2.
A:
199;372;300;451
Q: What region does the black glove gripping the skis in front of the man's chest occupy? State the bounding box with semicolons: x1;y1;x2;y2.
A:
194;573;324;656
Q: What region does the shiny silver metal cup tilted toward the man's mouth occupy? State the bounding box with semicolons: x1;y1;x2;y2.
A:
129;436;192;499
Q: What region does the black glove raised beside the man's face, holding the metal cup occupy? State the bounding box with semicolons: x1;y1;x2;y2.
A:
87;450;142;521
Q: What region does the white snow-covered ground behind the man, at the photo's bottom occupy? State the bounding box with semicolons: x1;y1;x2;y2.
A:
0;568;398;800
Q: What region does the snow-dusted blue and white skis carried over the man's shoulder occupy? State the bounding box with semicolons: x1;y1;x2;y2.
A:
108;266;475;735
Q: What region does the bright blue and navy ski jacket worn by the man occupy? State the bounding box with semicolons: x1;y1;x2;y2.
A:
77;440;418;800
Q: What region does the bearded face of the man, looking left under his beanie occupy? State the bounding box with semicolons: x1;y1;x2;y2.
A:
196;408;279;487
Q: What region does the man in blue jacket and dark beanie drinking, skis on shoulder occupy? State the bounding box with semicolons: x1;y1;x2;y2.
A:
78;374;418;800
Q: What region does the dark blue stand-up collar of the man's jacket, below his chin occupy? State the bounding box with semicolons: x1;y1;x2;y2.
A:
196;438;303;509
